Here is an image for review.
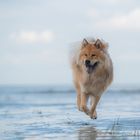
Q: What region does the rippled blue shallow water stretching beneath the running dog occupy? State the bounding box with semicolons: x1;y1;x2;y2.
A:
0;86;140;140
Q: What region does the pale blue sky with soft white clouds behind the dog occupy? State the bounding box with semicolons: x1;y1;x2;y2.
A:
0;0;140;85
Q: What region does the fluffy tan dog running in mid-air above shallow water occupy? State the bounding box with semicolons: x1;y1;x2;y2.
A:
71;39;113;119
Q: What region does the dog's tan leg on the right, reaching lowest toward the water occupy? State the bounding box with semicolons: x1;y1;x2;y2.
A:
90;96;100;119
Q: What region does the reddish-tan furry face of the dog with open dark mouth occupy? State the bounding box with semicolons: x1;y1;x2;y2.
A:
79;39;106;74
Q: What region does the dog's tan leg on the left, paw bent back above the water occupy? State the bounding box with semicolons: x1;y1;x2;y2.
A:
80;93;90;115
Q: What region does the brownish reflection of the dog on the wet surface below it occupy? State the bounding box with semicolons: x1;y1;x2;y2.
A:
78;126;97;140
